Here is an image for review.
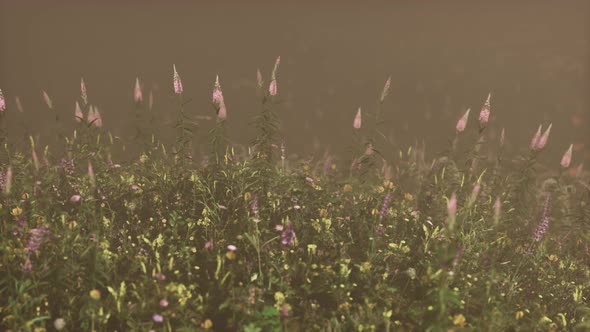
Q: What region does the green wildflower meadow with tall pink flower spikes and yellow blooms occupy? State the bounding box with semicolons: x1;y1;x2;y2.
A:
0;57;590;332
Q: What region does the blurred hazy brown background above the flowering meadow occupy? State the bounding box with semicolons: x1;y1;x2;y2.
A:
0;0;590;167
